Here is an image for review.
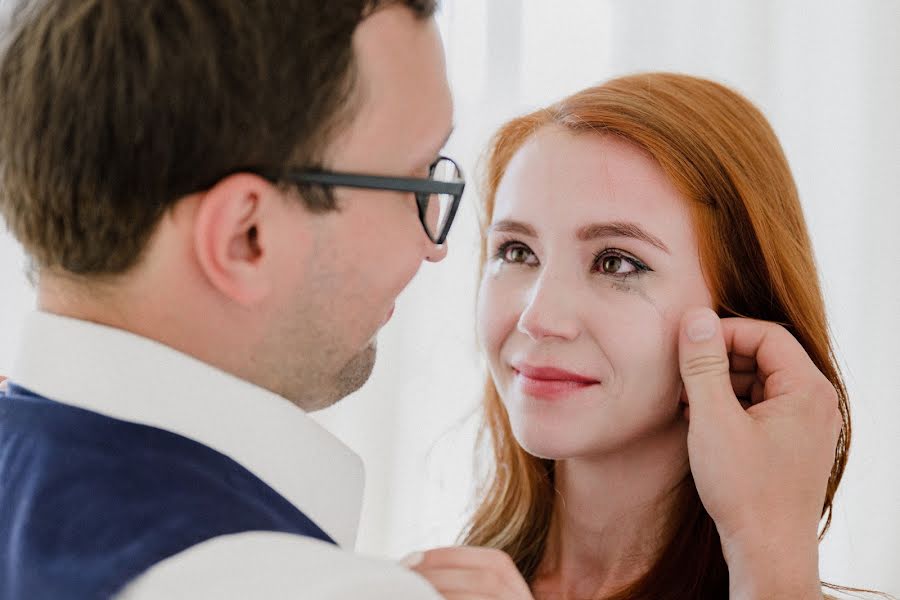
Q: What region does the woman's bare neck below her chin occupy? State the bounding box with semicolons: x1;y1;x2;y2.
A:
534;421;689;600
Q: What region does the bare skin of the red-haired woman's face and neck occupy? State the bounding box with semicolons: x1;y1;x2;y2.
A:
478;128;711;598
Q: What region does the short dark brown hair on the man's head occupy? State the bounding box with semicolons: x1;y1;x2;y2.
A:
0;0;435;275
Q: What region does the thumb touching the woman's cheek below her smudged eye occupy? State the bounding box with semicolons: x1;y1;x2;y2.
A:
678;308;744;421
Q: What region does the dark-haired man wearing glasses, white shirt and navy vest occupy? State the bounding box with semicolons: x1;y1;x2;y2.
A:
0;0;844;599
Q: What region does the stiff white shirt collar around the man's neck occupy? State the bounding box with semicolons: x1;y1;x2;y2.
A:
10;312;364;548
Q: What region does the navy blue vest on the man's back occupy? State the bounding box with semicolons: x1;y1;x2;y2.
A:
0;385;334;600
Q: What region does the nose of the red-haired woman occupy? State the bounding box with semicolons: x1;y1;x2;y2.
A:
517;276;580;340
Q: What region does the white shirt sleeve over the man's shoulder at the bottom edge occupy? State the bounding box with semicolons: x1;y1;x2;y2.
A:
119;532;440;600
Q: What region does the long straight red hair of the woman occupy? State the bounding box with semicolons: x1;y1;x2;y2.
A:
463;73;850;600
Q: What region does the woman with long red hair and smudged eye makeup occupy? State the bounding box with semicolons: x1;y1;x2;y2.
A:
408;73;880;600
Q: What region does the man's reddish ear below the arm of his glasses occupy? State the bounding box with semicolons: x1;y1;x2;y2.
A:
193;173;284;307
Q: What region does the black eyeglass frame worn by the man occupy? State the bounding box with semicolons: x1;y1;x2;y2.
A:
251;156;466;246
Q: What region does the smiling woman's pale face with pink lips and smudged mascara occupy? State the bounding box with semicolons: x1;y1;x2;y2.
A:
478;127;711;459
